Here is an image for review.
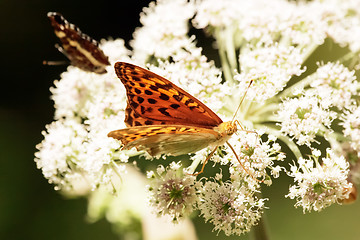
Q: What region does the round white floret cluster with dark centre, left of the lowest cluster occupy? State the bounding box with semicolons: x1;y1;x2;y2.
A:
148;162;200;222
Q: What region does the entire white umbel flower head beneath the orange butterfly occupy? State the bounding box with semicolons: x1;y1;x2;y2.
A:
35;0;360;235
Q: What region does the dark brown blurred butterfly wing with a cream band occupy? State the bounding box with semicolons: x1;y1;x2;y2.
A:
48;12;110;73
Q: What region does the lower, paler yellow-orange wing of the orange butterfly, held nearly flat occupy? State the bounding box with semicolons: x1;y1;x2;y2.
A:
108;125;221;156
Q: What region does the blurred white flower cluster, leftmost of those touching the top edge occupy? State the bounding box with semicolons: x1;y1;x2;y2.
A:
130;0;194;62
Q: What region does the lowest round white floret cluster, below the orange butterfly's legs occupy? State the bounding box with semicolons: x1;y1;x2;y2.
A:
199;178;265;236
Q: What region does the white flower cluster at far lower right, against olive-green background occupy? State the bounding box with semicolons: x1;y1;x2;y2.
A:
286;149;352;212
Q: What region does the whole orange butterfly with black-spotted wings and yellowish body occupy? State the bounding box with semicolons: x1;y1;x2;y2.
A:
108;62;250;175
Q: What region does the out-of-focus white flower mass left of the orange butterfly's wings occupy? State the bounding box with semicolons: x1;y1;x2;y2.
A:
35;41;129;191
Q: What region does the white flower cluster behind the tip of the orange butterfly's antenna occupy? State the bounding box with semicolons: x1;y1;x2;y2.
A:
234;45;304;102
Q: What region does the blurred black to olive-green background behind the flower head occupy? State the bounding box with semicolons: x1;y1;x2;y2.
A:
0;0;360;240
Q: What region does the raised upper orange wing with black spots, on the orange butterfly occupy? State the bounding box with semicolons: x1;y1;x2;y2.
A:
115;62;222;129
